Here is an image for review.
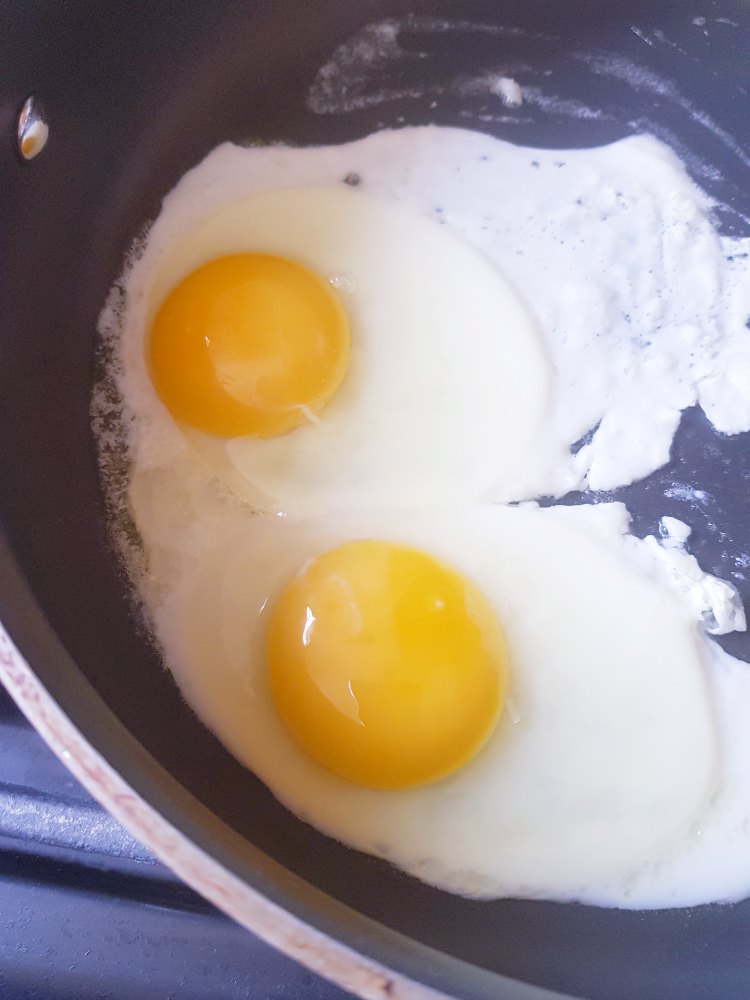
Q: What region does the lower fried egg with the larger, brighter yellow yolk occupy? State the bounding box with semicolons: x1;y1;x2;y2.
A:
137;496;717;902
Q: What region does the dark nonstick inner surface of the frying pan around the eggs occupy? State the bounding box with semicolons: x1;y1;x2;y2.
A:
0;0;750;1000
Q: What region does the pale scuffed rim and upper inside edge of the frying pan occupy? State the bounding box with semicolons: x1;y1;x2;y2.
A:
0;532;576;1000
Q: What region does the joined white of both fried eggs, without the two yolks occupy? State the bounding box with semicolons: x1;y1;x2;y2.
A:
96;128;750;906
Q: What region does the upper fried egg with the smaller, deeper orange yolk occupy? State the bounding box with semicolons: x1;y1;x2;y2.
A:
133;184;550;515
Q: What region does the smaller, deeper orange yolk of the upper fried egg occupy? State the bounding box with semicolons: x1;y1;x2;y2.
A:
148;253;350;437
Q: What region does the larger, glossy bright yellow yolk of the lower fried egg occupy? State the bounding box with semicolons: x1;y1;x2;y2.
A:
266;541;508;788
